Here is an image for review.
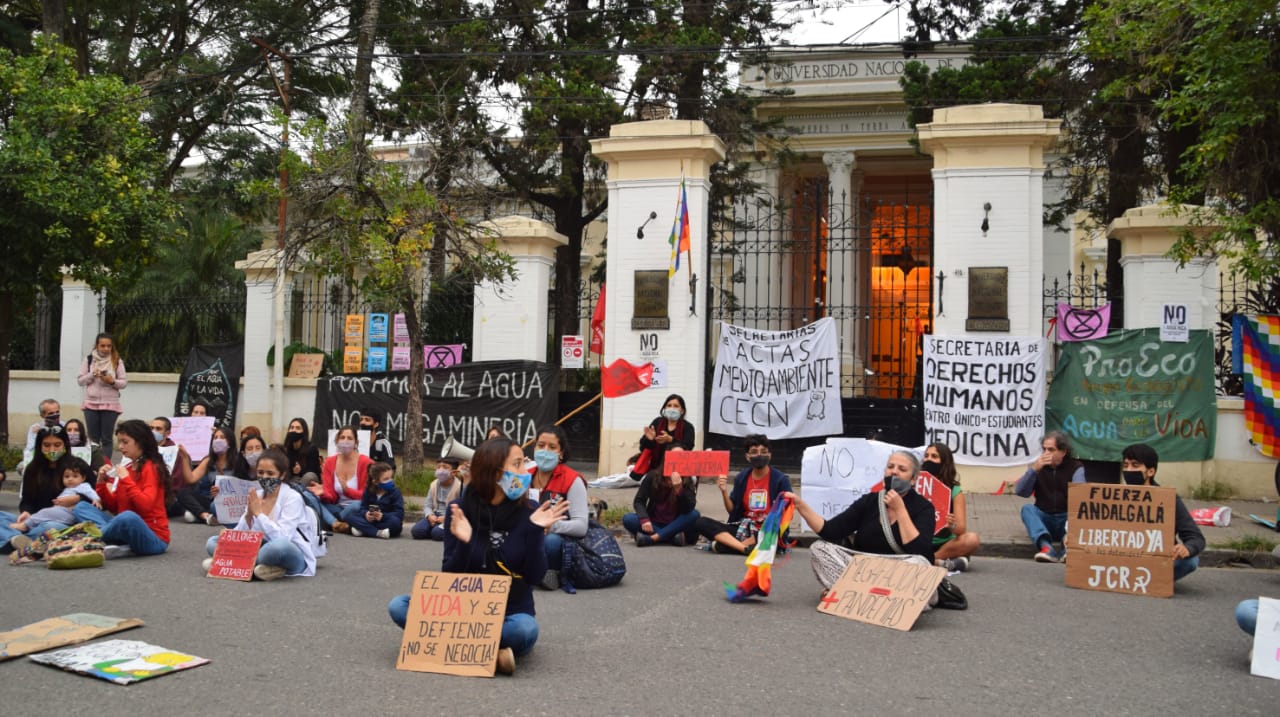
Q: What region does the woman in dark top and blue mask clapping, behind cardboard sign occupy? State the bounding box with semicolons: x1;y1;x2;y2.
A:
387;438;570;675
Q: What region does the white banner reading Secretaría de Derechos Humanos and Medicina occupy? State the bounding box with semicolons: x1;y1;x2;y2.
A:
924;335;1046;466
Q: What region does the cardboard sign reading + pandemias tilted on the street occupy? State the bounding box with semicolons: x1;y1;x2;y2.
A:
818;554;947;631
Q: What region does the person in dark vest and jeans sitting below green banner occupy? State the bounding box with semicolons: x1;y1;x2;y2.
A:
1014;430;1084;562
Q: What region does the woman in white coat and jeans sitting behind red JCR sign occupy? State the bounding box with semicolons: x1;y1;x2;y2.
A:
204;448;316;580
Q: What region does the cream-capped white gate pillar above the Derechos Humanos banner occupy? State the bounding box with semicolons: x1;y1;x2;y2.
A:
916;104;1061;335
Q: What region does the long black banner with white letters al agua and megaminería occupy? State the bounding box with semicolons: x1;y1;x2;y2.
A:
311;361;559;456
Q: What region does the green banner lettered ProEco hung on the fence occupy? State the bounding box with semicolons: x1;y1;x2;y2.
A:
1044;329;1217;462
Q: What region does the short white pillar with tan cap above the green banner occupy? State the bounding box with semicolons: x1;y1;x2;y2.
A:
1107;205;1217;330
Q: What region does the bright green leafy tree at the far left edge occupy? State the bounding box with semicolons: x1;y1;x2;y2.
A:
0;37;178;440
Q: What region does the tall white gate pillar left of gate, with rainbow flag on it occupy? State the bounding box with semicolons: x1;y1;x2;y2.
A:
591;119;724;475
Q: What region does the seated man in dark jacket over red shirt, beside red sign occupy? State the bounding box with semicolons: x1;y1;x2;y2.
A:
696;434;791;556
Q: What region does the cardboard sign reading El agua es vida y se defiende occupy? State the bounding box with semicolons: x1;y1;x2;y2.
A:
396;570;511;677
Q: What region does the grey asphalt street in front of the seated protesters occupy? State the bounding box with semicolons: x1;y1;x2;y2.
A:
0;493;1280;717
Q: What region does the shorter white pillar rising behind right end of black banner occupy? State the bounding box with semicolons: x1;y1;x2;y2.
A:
471;215;568;361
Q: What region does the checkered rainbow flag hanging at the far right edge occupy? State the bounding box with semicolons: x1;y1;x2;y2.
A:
1231;314;1280;458
